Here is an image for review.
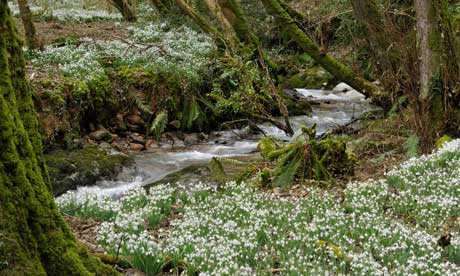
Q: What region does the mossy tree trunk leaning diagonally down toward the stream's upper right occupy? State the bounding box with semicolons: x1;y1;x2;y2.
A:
262;0;384;101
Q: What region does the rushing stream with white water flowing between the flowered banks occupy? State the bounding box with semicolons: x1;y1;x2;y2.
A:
67;89;374;197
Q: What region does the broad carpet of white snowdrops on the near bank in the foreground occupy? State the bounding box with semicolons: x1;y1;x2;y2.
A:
57;140;460;275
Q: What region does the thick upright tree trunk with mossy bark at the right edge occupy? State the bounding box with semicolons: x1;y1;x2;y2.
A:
414;0;460;152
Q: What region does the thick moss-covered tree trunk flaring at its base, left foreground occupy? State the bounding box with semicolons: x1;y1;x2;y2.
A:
0;0;117;276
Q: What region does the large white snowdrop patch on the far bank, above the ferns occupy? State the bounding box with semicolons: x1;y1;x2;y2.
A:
30;20;213;87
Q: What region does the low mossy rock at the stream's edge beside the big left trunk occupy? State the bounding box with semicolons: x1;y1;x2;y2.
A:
45;146;132;195
